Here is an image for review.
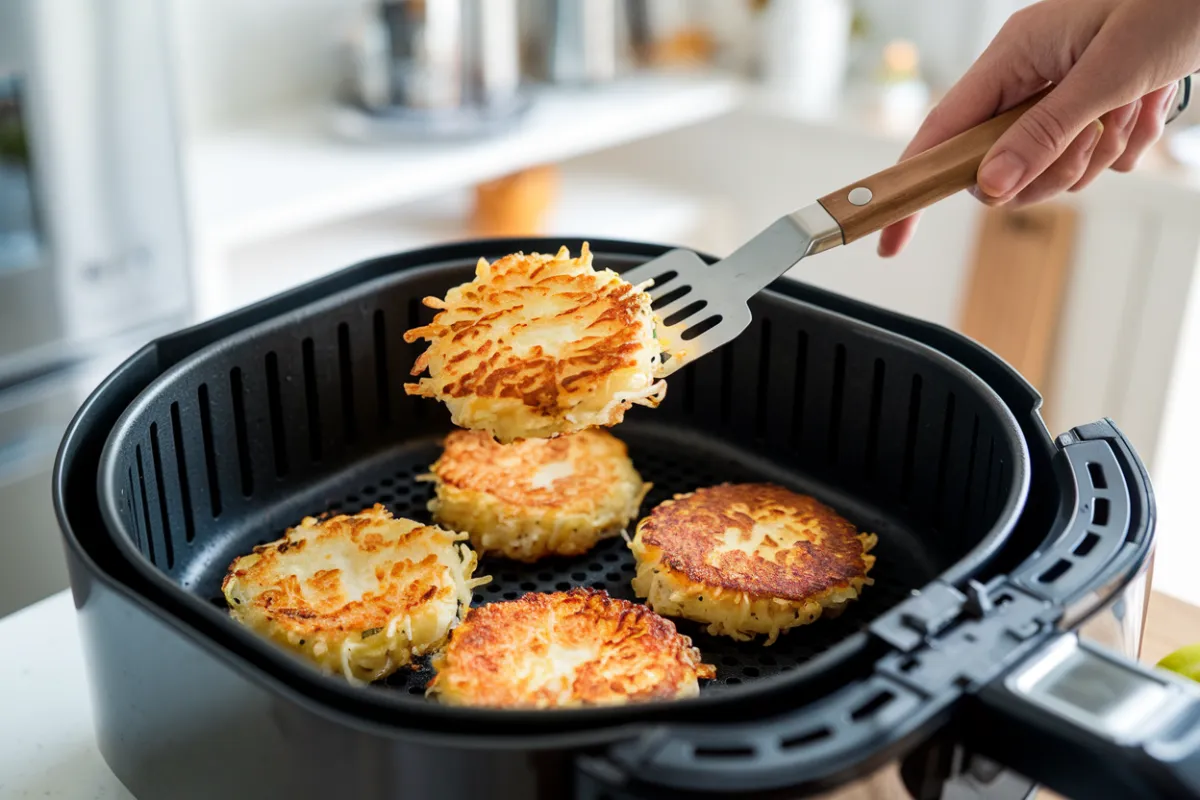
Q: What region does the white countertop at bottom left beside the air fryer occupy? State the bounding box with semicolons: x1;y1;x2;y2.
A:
0;591;133;800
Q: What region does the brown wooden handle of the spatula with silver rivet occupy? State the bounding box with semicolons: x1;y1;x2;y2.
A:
820;90;1049;245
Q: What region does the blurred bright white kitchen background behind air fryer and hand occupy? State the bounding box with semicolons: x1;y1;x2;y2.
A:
0;0;1200;615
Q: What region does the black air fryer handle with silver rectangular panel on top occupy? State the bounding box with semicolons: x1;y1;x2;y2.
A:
967;633;1200;800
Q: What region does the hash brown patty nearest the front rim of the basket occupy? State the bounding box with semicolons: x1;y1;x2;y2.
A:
428;589;716;709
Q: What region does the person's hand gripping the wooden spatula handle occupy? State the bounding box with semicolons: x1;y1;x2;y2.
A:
880;0;1200;257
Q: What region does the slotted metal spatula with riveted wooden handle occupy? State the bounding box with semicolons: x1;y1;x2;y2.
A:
622;92;1044;375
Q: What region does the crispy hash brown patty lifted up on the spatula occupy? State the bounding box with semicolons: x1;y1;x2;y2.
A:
404;245;666;443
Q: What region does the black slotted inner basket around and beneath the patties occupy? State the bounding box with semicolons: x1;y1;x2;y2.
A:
100;244;1028;712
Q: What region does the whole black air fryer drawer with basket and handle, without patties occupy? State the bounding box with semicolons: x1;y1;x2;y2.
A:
54;240;1200;800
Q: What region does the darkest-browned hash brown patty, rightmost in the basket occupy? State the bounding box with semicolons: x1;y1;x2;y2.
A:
631;483;876;644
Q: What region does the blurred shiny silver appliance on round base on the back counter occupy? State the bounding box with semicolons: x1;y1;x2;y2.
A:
335;0;528;139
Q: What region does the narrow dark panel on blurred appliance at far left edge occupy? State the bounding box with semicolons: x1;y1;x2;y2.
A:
0;74;42;276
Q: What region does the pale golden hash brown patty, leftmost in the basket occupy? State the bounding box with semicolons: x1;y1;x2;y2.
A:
221;505;487;684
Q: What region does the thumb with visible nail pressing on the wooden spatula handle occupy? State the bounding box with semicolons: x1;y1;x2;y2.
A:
976;74;1109;203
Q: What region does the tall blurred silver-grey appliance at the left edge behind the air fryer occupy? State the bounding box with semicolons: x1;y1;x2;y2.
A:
0;0;190;615
